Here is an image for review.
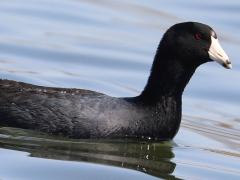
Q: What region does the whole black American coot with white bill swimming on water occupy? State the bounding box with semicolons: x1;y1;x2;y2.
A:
0;22;231;140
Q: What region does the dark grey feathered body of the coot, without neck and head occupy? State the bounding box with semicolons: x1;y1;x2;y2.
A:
0;80;181;139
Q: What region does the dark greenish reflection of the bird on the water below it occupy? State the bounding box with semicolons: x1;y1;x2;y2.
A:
0;128;176;178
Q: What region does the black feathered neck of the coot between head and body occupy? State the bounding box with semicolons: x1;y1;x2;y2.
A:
138;46;197;103
